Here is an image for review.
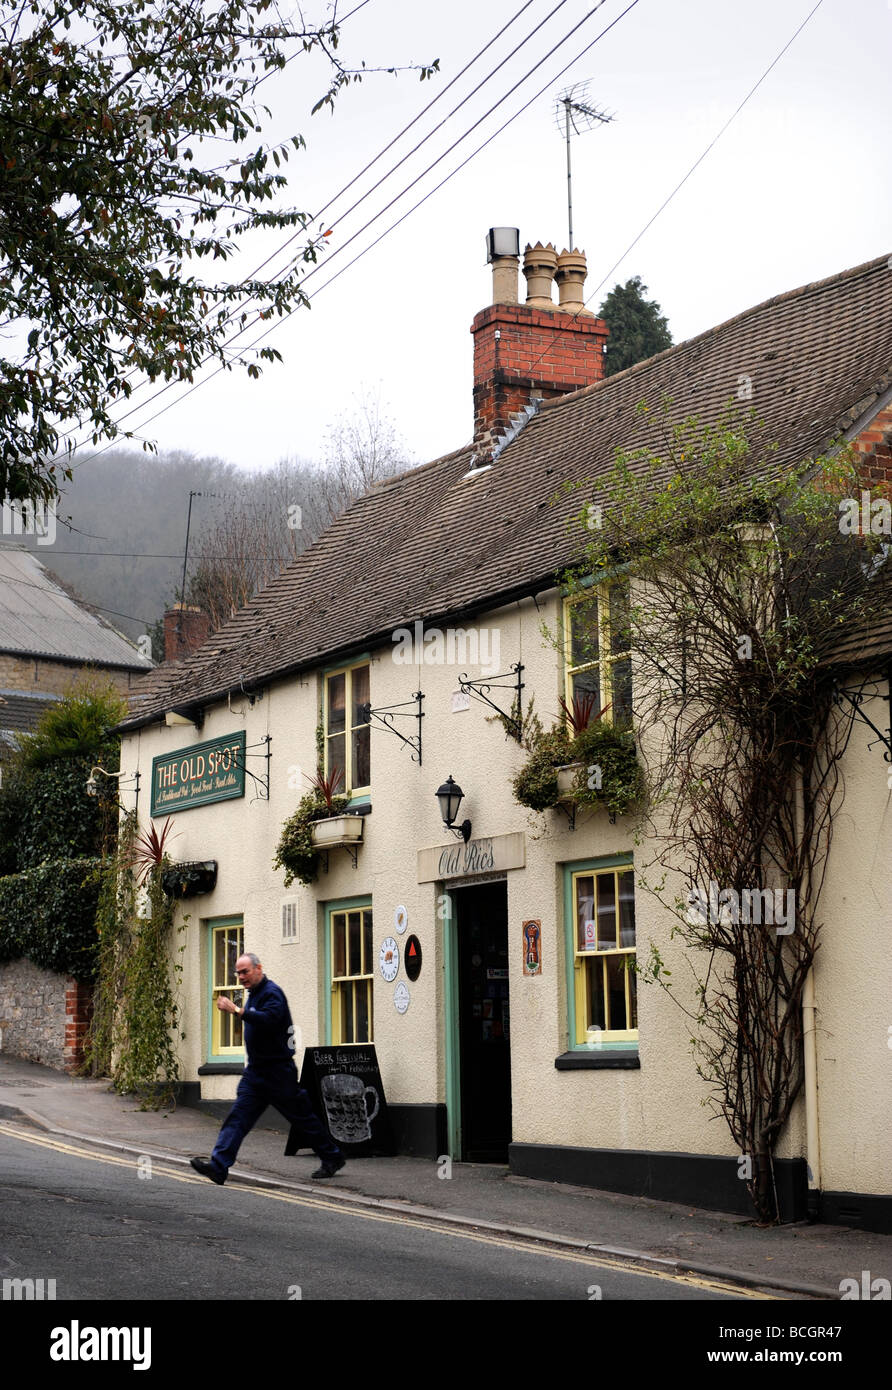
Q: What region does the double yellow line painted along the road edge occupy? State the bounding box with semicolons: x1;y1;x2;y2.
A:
0;1122;782;1301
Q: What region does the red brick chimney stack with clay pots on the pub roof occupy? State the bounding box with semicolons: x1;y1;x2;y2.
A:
471;227;607;467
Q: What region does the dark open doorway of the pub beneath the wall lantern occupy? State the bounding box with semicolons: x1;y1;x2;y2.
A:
453;880;511;1163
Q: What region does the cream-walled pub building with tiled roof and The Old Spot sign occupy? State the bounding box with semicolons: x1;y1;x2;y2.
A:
121;236;892;1229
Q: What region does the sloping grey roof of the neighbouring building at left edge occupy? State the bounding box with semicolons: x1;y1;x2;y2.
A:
0;545;151;671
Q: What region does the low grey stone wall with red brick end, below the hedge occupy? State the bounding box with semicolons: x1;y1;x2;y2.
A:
0;959;92;1072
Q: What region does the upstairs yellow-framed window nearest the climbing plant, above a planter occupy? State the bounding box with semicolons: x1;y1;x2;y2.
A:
564;581;632;727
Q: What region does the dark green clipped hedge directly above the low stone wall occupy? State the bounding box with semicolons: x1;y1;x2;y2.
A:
0;859;101;983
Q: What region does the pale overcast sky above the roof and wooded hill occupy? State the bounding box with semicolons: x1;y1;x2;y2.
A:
64;0;892;468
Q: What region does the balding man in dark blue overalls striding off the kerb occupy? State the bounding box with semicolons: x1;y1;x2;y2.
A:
192;951;346;1183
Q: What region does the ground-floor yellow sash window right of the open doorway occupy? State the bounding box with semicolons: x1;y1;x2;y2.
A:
567;860;638;1047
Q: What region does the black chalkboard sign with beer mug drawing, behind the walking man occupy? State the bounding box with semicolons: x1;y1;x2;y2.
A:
285;1043;393;1156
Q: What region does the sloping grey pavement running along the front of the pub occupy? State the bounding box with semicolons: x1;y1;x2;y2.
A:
0;1056;892;1300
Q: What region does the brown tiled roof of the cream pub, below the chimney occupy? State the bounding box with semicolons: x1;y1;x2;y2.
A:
121;257;892;728
